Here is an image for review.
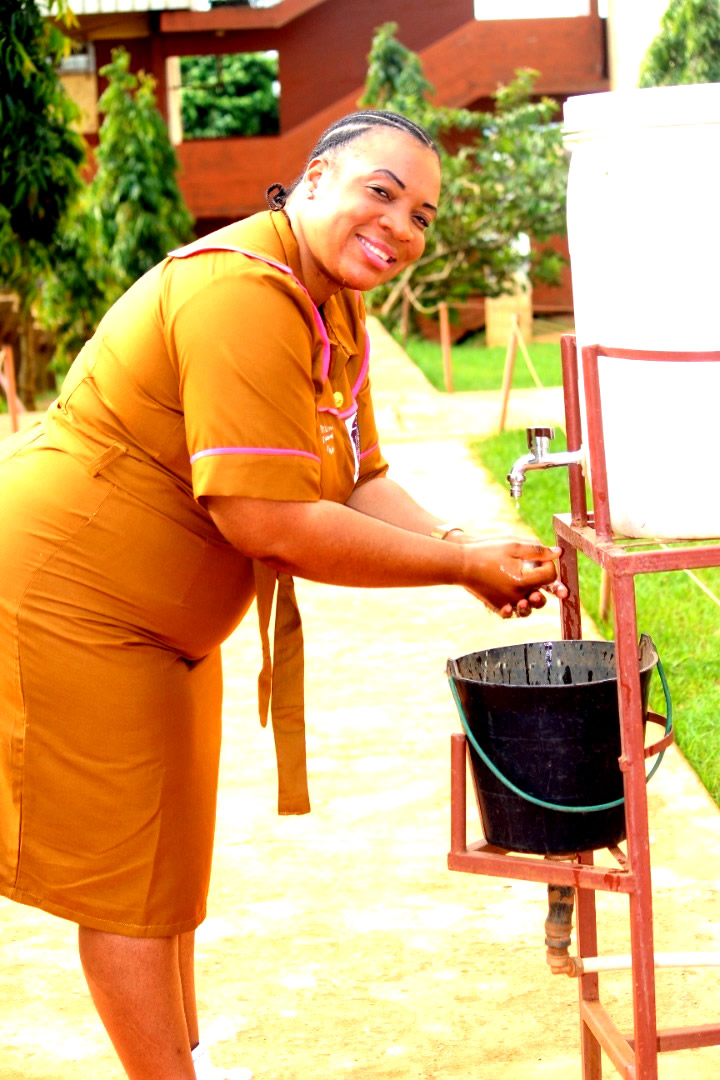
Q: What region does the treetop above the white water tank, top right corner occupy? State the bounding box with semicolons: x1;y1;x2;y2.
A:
638;0;720;86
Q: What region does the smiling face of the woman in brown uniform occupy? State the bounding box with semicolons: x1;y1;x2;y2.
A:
288;129;440;303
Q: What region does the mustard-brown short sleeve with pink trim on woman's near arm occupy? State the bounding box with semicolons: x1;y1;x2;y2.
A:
166;261;321;501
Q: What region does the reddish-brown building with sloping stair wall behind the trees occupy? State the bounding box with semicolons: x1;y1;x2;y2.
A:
63;0;608;307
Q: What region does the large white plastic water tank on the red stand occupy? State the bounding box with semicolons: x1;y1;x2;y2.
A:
565;83;720;539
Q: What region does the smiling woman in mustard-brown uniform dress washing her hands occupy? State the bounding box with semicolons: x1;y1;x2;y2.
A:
0;112;563;1080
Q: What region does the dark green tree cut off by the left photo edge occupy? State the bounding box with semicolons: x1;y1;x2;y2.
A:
0;0;85;408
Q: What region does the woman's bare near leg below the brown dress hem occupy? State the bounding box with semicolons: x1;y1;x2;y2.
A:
80;927;195;1080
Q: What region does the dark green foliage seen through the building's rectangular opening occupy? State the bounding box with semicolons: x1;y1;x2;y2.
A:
180;53;280;138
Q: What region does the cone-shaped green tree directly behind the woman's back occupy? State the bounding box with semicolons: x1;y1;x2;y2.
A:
40;49;192;375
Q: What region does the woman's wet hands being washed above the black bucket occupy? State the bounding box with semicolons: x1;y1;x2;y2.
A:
446;532;568;619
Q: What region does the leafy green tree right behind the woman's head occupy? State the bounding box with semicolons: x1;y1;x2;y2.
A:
359;23;567;322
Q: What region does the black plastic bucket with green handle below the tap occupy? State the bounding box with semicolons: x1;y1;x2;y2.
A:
448;634;657;855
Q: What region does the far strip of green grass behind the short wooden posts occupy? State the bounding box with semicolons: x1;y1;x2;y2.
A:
404;334;562;390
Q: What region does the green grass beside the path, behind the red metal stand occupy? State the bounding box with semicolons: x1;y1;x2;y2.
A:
472;431;720;804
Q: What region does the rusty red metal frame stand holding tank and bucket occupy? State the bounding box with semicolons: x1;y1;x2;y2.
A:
448;335;720;1080
